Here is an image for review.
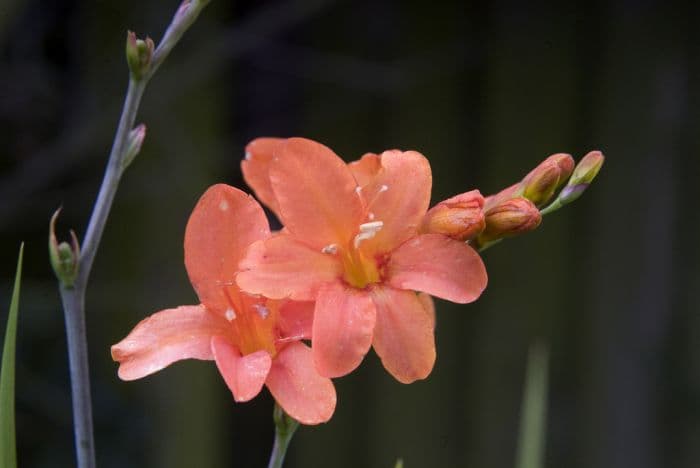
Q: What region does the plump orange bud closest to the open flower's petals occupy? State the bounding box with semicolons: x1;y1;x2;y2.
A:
420;190;486;241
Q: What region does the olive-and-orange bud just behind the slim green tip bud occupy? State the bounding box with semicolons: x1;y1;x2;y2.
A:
521;153;574;206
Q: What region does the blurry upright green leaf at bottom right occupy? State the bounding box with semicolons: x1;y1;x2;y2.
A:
516;343;549;468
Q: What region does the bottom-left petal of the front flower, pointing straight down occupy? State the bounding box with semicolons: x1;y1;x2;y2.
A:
312;282;376;377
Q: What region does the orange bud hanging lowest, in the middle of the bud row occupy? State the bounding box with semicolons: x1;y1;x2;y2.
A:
478;197;542;245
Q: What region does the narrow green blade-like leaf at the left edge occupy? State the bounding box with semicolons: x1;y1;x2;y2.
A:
0;243;24;468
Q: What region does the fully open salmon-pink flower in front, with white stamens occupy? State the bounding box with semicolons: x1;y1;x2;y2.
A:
236;138;486;383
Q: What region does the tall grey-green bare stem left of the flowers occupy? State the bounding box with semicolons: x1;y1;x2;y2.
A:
54;0;209;468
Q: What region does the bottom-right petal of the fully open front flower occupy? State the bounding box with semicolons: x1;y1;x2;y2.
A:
372;288;435;384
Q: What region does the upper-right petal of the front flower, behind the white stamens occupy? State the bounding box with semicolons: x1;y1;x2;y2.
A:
361;150;432;252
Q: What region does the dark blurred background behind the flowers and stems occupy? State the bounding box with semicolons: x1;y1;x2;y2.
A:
0;0;700;468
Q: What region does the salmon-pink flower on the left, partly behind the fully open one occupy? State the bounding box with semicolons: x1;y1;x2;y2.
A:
112;184;336;424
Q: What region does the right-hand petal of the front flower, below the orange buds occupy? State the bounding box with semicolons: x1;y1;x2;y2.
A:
387;234;487;304
